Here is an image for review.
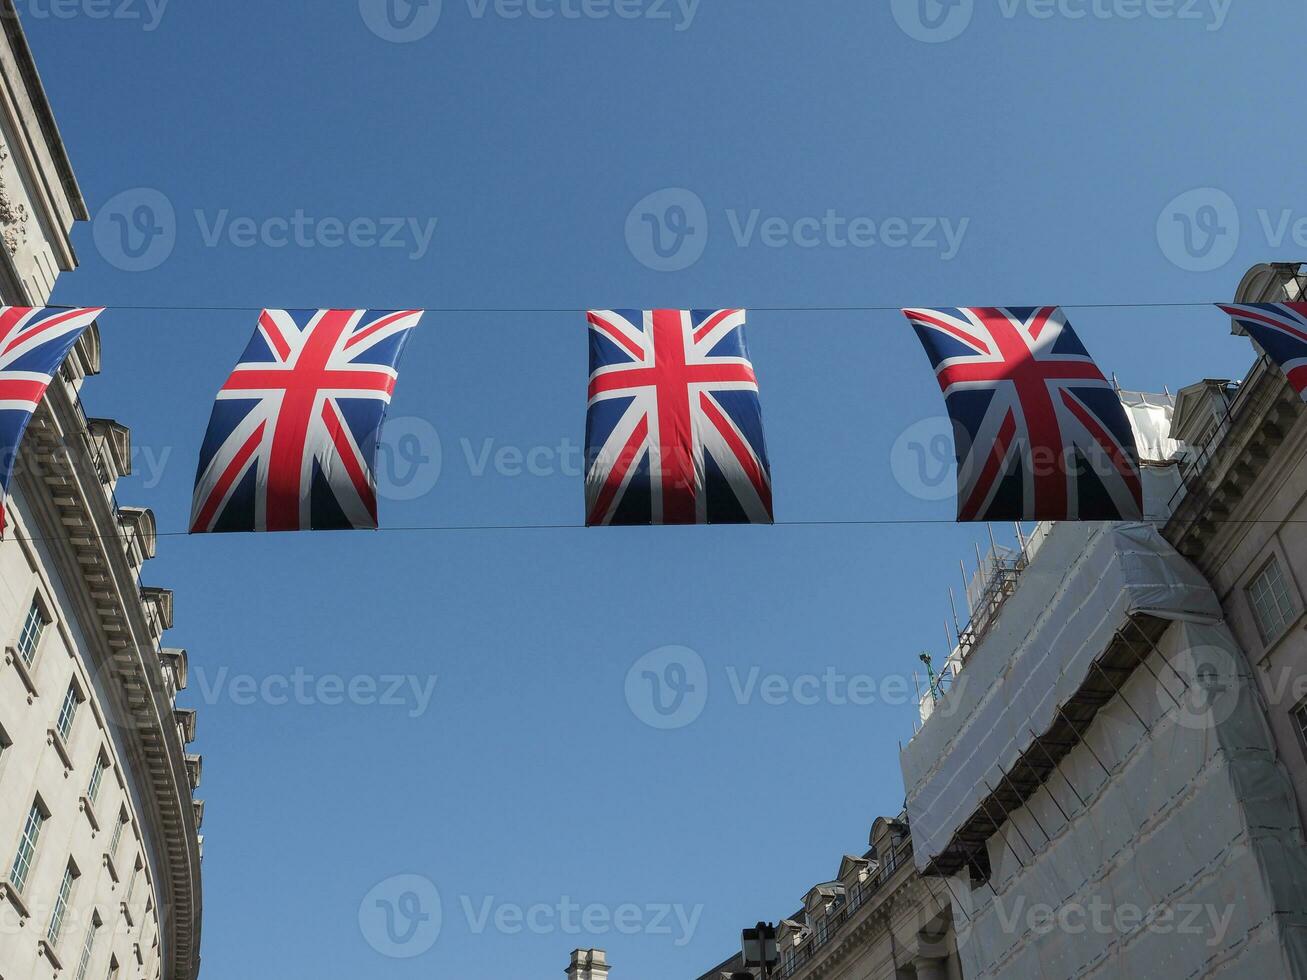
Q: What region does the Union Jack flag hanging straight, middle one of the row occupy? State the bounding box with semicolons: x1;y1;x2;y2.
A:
586;310;772;527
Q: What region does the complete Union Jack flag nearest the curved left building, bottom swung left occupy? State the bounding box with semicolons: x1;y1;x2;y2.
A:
191;310;422;533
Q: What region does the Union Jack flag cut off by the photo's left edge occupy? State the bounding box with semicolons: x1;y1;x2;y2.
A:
0;306;105;532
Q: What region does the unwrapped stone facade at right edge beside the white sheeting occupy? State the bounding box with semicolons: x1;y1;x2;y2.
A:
1165;263;1307;822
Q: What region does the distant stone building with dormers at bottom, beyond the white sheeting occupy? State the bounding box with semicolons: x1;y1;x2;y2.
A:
699;815;962;980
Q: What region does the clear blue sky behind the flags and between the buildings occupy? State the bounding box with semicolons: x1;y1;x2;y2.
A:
20;0;1307;980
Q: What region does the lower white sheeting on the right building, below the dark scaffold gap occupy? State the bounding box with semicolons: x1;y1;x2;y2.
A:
956;622;1307;980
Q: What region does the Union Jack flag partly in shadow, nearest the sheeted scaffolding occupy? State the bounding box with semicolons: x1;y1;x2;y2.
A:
903;306;1144;521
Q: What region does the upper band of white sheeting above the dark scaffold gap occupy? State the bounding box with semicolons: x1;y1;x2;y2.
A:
901;523;1221;868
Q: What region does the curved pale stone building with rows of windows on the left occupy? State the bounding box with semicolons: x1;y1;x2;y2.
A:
0;0;203;980
